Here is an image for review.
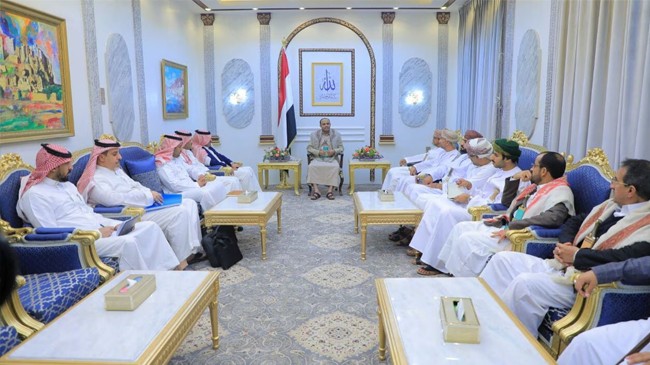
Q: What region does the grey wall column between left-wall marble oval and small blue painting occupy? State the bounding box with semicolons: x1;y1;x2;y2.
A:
131;0;149;146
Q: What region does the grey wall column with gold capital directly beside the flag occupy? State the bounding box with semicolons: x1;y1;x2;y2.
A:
257;13;275;145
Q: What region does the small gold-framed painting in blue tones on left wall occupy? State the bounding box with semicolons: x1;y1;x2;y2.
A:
161;60;189;119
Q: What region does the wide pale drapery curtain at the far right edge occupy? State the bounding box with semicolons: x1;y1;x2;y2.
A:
547;0;650;169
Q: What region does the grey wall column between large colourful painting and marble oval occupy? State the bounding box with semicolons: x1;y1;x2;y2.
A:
81;0;104;138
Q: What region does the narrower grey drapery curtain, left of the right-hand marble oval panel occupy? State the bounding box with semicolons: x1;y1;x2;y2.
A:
457;0;506;139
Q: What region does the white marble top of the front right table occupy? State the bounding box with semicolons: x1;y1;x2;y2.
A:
380;278;550;365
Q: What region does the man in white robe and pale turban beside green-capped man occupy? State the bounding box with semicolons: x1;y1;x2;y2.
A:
409;138;521;268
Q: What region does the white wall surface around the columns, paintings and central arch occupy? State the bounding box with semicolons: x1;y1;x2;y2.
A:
0;0;458;183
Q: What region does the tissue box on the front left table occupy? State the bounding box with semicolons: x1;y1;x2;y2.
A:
104;274;156;311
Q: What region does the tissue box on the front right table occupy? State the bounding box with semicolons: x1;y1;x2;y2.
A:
440;297;480;343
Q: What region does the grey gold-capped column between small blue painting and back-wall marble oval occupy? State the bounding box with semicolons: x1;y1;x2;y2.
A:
201;13;220;145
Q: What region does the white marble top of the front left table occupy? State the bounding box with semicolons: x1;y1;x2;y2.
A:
9;271;209;363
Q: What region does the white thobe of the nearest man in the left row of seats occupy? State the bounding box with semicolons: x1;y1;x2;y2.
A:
16;176;179;270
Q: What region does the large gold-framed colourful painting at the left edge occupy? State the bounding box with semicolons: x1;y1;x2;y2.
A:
0;0;74;143
